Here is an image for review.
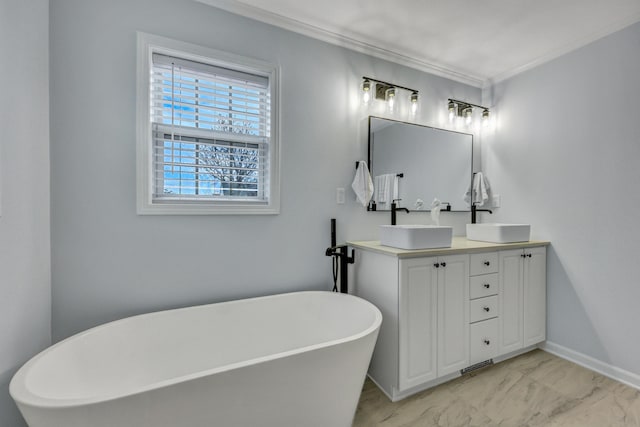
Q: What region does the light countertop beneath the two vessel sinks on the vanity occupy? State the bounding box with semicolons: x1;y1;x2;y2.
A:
347;237;550;258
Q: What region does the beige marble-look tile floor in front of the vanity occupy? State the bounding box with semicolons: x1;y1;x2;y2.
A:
353;350;640;427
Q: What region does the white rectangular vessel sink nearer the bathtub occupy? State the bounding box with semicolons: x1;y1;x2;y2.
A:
380;225;453;249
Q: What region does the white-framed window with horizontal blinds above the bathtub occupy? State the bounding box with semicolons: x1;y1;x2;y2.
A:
138;33;279;214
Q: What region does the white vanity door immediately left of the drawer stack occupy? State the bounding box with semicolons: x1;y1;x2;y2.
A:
437;255;469;376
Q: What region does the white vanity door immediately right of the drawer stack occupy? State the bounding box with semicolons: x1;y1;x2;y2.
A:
498;249;524;354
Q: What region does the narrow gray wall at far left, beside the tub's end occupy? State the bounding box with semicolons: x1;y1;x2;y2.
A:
0;0;51;427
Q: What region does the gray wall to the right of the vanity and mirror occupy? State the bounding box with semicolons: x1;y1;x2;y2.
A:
482;24;640;374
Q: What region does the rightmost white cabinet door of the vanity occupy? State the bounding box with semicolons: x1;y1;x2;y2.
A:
523;247;547;346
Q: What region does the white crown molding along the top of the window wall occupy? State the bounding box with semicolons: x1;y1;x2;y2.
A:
195;0;486;88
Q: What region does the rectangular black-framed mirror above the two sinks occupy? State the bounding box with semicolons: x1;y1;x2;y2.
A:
368;116;473;212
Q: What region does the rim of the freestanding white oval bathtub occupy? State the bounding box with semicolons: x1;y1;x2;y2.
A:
9;291;382;409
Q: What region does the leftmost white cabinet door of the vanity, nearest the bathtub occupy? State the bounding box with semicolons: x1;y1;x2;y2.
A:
398;257;438;390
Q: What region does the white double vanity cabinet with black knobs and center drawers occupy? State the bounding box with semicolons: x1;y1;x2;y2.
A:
349;237;548;401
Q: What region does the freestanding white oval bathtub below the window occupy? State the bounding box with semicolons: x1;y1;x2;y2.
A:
10;292;382;427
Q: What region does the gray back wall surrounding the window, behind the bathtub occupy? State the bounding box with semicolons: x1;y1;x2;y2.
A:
50;0;481;340
